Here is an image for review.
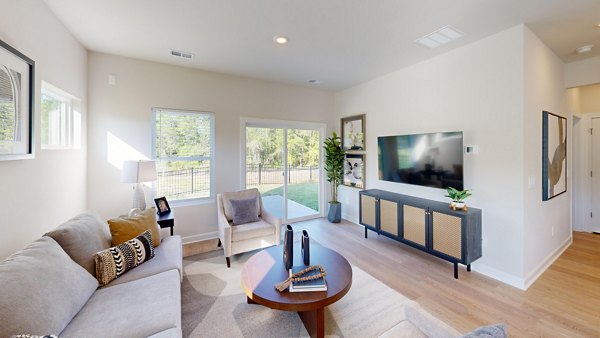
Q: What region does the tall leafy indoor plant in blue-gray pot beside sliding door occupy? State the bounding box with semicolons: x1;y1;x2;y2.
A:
323;132;346;223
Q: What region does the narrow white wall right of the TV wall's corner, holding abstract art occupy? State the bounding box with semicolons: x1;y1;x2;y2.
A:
522;27;572;287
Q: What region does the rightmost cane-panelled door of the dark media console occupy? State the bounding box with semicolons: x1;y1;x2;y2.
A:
431;211;463;261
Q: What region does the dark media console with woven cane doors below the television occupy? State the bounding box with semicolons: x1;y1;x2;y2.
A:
359;189;481;278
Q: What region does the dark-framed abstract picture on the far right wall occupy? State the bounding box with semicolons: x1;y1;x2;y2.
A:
542;111;567;201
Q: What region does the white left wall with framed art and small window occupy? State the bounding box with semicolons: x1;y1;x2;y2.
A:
0;0;87;259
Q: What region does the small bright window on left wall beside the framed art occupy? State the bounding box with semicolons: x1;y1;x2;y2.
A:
41;81;81;149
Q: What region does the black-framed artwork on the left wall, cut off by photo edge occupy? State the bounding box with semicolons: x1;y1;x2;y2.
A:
0;40;35;161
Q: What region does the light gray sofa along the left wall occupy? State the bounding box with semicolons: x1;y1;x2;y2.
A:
0;212;183;338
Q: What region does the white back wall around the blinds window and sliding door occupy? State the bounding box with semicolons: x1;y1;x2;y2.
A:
88;52;333;241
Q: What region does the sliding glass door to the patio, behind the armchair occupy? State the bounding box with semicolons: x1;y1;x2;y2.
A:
244;122;321;222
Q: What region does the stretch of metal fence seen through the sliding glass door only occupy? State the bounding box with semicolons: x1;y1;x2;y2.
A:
246;164;319;186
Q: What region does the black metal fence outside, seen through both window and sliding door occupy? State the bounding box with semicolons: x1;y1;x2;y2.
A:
156;164;319;200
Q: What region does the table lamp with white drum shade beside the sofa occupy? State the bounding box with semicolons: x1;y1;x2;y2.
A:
121;160;157;210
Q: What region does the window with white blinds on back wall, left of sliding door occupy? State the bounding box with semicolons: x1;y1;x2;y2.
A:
152;108;214;200
